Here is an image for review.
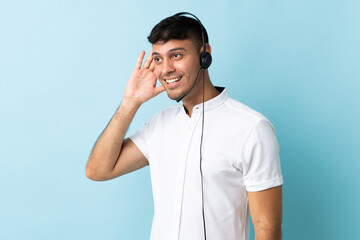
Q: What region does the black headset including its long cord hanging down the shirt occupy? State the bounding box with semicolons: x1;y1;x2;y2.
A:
173;12;212;240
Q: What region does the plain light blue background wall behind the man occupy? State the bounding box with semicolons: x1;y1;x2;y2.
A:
0;0;360;240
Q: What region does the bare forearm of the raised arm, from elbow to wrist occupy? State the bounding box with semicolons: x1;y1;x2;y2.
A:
86;98;141;179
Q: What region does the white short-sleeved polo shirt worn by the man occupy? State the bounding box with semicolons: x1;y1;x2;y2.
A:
130;88;283;240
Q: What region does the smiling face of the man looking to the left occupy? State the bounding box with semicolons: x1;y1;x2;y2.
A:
152;39;200;100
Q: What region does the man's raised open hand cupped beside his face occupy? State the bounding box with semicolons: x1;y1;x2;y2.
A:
124;51;165;104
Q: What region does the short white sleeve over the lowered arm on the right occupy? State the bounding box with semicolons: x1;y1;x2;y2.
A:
240;119;283;192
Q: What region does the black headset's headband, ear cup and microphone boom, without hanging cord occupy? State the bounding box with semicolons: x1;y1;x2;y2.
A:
173;12;212;102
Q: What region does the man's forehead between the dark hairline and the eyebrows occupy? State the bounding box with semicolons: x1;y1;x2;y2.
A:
152;39;196;55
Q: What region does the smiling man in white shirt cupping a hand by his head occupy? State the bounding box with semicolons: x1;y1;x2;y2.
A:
86;14;283;240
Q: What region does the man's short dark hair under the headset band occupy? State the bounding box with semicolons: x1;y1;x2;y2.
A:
148;16;209;49
